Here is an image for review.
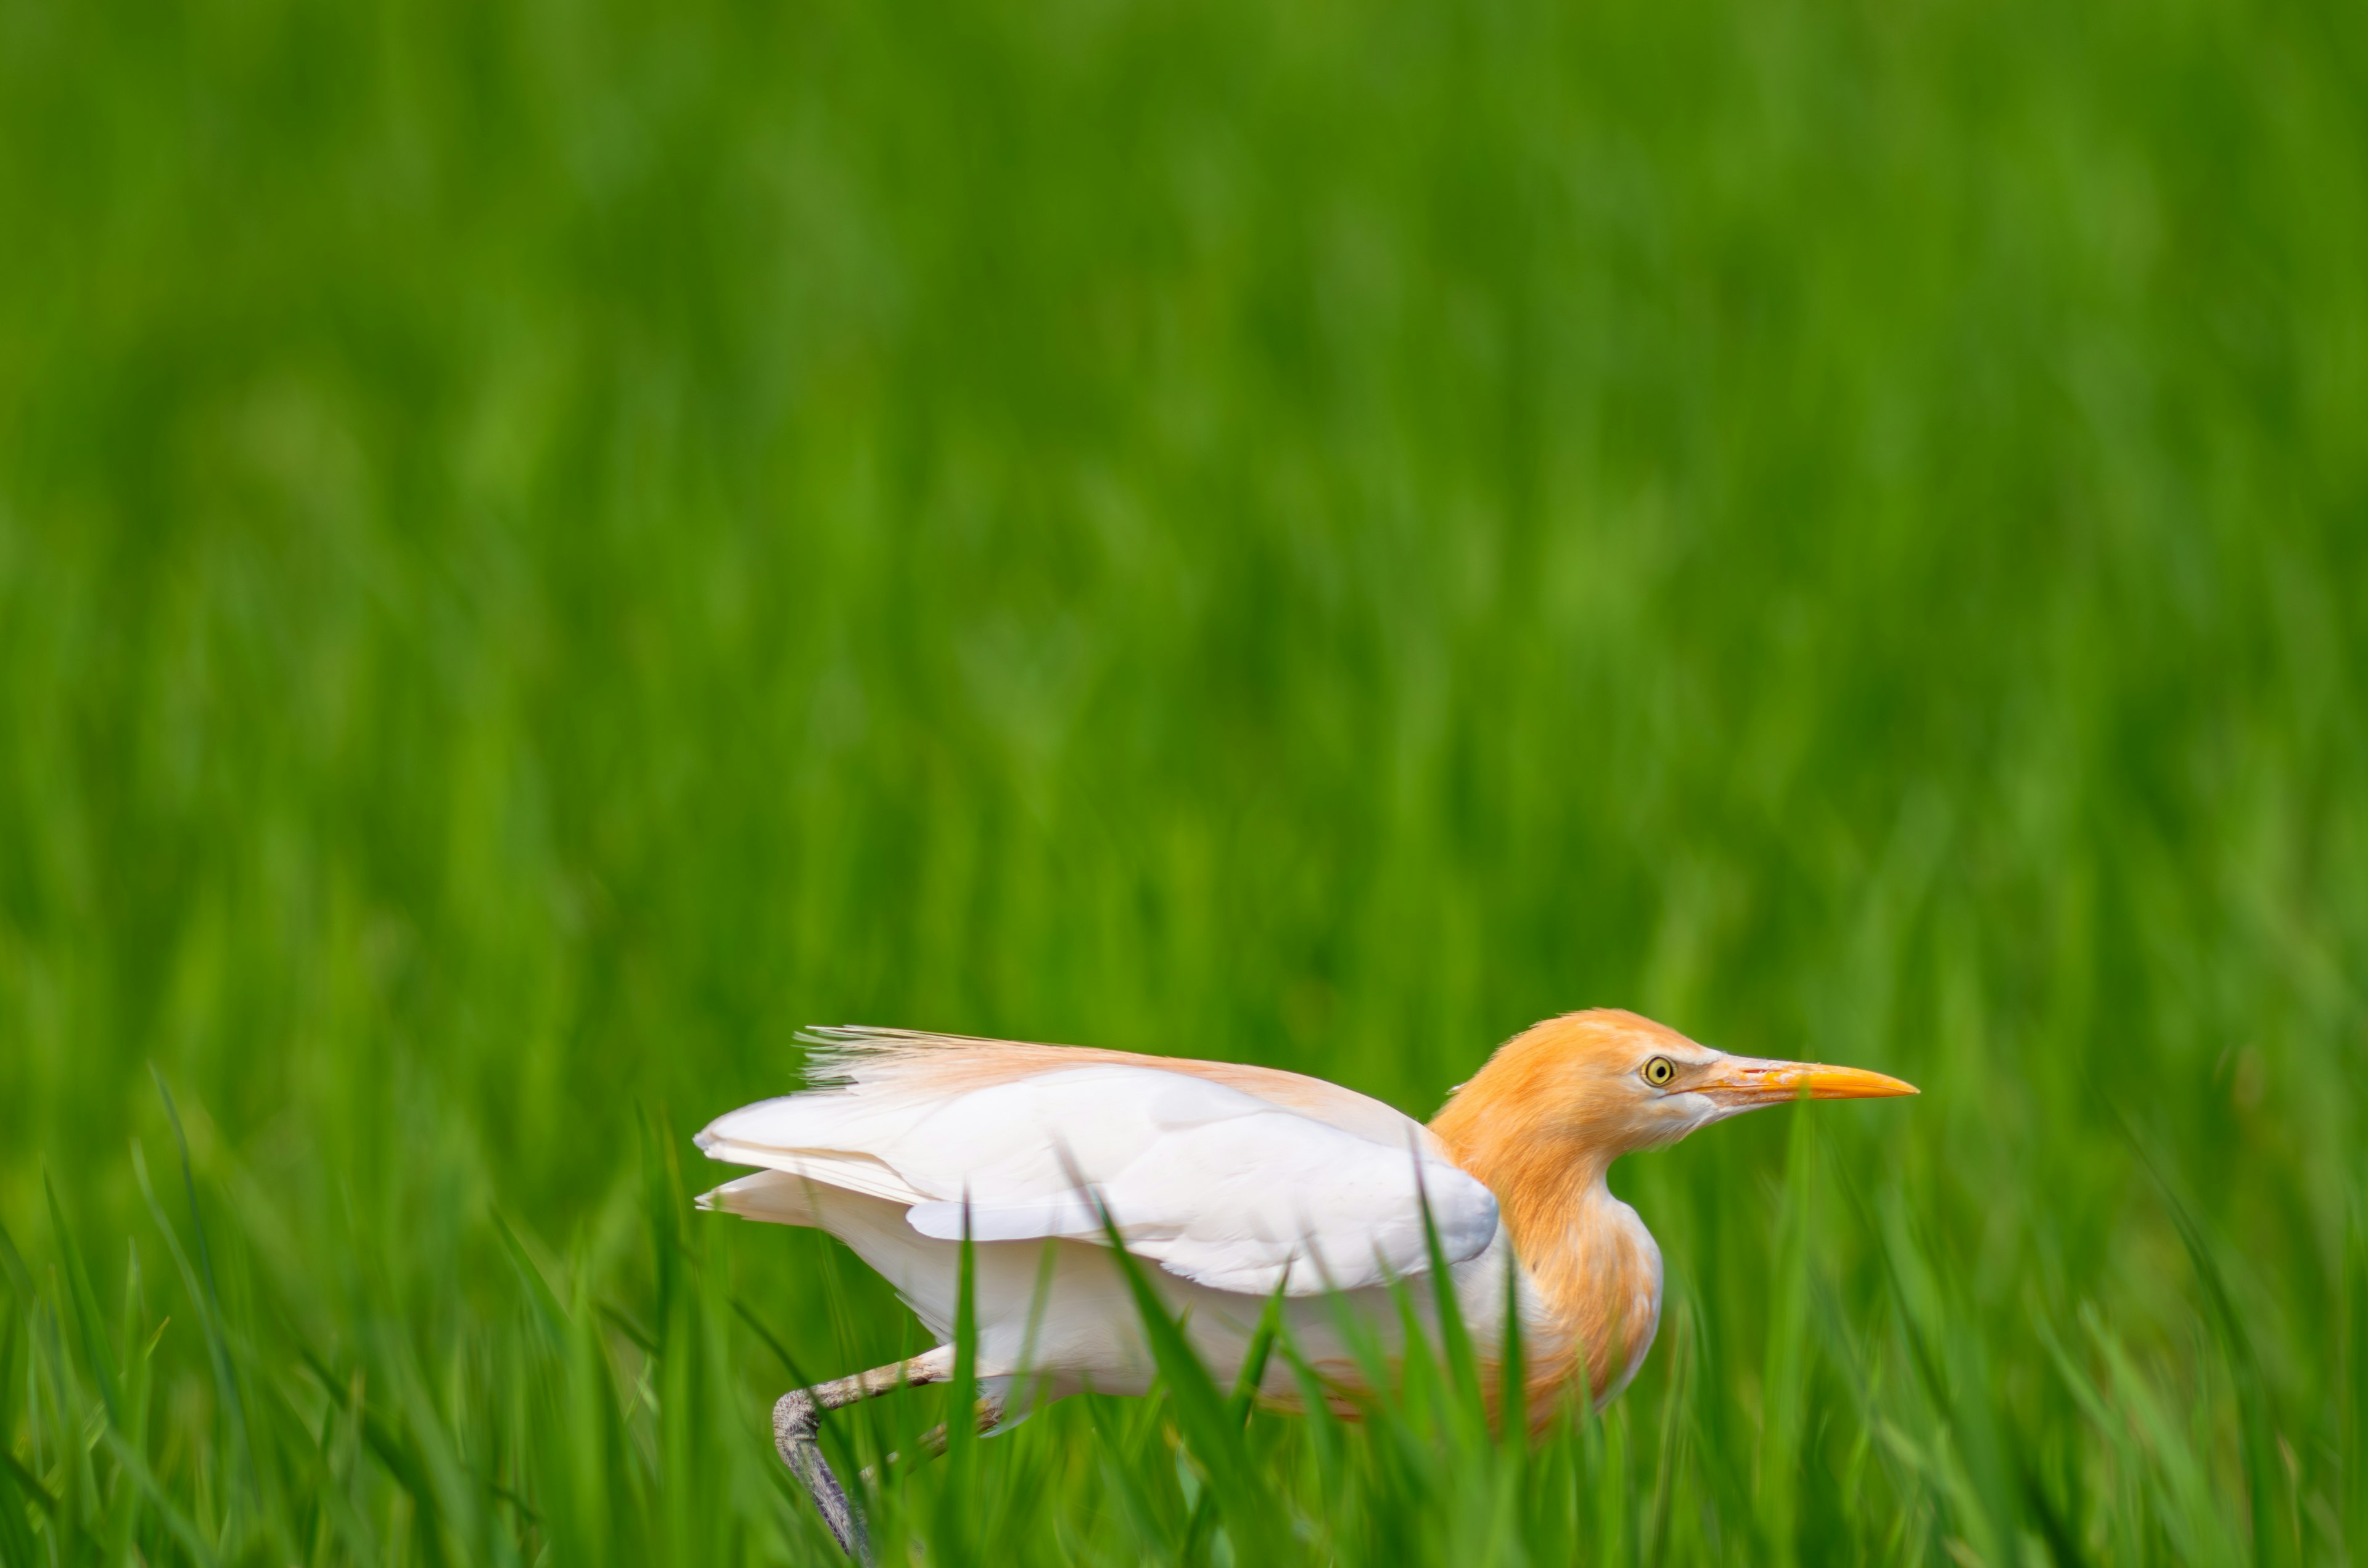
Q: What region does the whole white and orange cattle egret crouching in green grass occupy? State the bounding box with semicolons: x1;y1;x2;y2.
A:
699;1009;1916;1551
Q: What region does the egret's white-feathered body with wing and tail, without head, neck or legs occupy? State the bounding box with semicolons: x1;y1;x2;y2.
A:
699;1030;1503;1393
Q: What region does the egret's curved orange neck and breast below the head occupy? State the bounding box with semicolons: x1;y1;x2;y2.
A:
1430;1099;1660;1411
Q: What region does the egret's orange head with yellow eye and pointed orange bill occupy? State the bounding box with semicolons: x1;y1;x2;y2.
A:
1433;1007;1916;1170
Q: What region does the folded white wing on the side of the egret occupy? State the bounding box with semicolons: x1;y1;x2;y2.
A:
699;1064;1497;1295
